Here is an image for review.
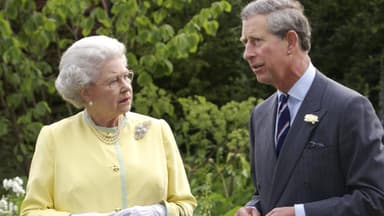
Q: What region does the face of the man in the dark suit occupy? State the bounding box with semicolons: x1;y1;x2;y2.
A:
240;15;288;87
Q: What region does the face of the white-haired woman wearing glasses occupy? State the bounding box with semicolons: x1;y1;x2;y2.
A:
85;58;133;124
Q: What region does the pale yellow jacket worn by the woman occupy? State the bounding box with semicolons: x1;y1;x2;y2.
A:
21;111;196;216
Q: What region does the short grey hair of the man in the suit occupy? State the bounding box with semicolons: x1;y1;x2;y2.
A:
240;0;311;52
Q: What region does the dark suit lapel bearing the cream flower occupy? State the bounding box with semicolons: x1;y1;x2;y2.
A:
268;72;326;207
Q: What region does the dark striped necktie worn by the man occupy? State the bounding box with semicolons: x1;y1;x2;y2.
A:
276;94;291;156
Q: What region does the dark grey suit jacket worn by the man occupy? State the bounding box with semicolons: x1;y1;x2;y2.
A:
247;72;384;216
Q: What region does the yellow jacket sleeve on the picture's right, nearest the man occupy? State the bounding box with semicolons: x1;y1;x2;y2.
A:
161;120;197;216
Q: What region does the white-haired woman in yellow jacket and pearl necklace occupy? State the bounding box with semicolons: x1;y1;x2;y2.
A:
21;36;196;216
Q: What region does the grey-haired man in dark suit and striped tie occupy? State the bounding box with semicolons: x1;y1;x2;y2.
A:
236;0;384;216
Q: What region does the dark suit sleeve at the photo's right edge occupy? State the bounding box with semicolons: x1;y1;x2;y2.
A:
304;96;384;216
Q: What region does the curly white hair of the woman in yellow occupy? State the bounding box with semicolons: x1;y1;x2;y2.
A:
55;35;127;108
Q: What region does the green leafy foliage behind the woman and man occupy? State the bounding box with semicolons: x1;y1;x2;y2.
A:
0;0;384;215
